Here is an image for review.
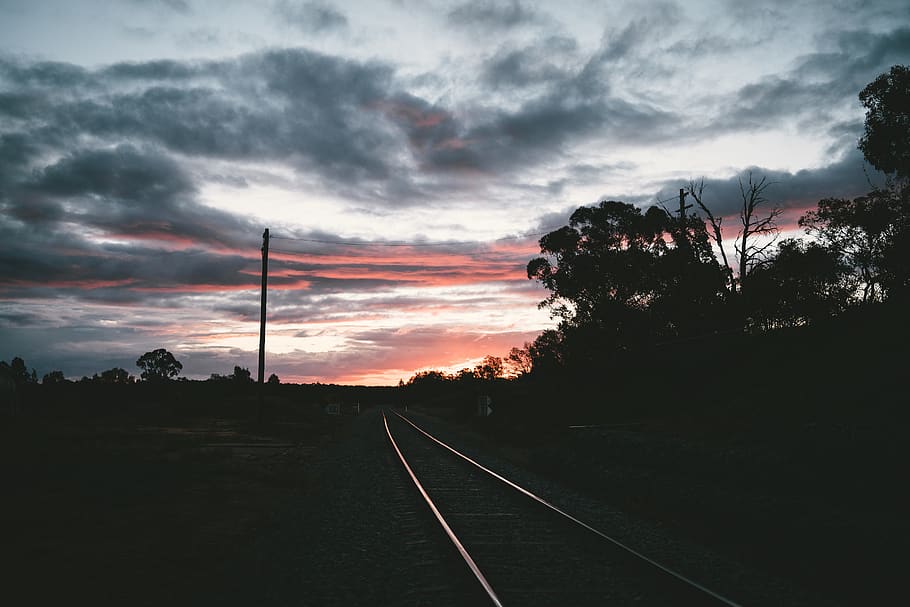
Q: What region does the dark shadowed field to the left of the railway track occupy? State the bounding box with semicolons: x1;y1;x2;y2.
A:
0;392;345;605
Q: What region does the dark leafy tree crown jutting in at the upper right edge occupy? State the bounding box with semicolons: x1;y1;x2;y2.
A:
859;65;910;178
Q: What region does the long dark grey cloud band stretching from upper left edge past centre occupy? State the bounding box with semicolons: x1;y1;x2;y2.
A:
0;40;676;206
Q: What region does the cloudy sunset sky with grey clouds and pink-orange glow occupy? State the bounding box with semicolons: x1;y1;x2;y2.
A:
0;0;910;385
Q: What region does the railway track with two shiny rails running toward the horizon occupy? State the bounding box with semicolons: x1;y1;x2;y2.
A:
383;413;738;607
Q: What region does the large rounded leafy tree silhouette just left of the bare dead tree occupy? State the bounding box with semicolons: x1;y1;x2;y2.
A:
527;201;724;352
